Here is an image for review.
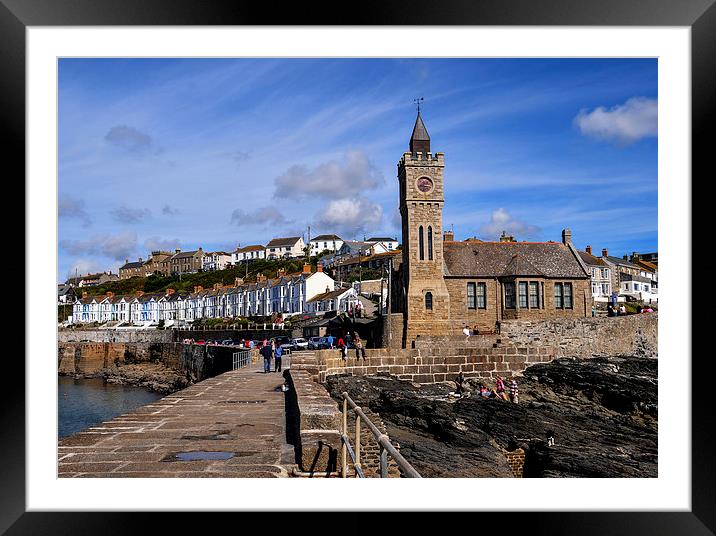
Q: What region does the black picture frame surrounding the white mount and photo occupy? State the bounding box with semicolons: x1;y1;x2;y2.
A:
0;0;716;536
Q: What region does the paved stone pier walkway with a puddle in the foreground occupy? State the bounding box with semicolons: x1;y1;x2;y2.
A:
58;363;295;478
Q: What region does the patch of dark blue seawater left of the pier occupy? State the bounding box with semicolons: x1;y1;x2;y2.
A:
58;376;162;439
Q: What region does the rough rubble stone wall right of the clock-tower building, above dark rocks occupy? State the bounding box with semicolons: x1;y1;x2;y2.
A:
500;313;658;357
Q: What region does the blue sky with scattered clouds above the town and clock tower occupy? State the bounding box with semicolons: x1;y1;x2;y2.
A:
57;59;657;280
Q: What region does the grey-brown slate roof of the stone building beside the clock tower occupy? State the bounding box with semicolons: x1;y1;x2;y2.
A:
443;241;588;278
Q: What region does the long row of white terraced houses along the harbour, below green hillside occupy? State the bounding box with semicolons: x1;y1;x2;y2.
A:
72;264;358;325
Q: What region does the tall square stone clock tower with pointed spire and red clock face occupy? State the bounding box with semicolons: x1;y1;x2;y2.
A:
398;110;450;347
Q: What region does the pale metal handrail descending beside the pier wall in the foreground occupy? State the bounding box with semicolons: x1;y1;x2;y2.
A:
341;392;422;478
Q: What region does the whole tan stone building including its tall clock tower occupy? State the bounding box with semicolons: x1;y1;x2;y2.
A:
388;112;592;347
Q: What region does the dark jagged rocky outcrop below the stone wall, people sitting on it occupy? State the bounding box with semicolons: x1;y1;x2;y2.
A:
326;358;658;477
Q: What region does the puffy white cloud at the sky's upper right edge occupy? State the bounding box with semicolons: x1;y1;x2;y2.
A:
574;97;658;145
